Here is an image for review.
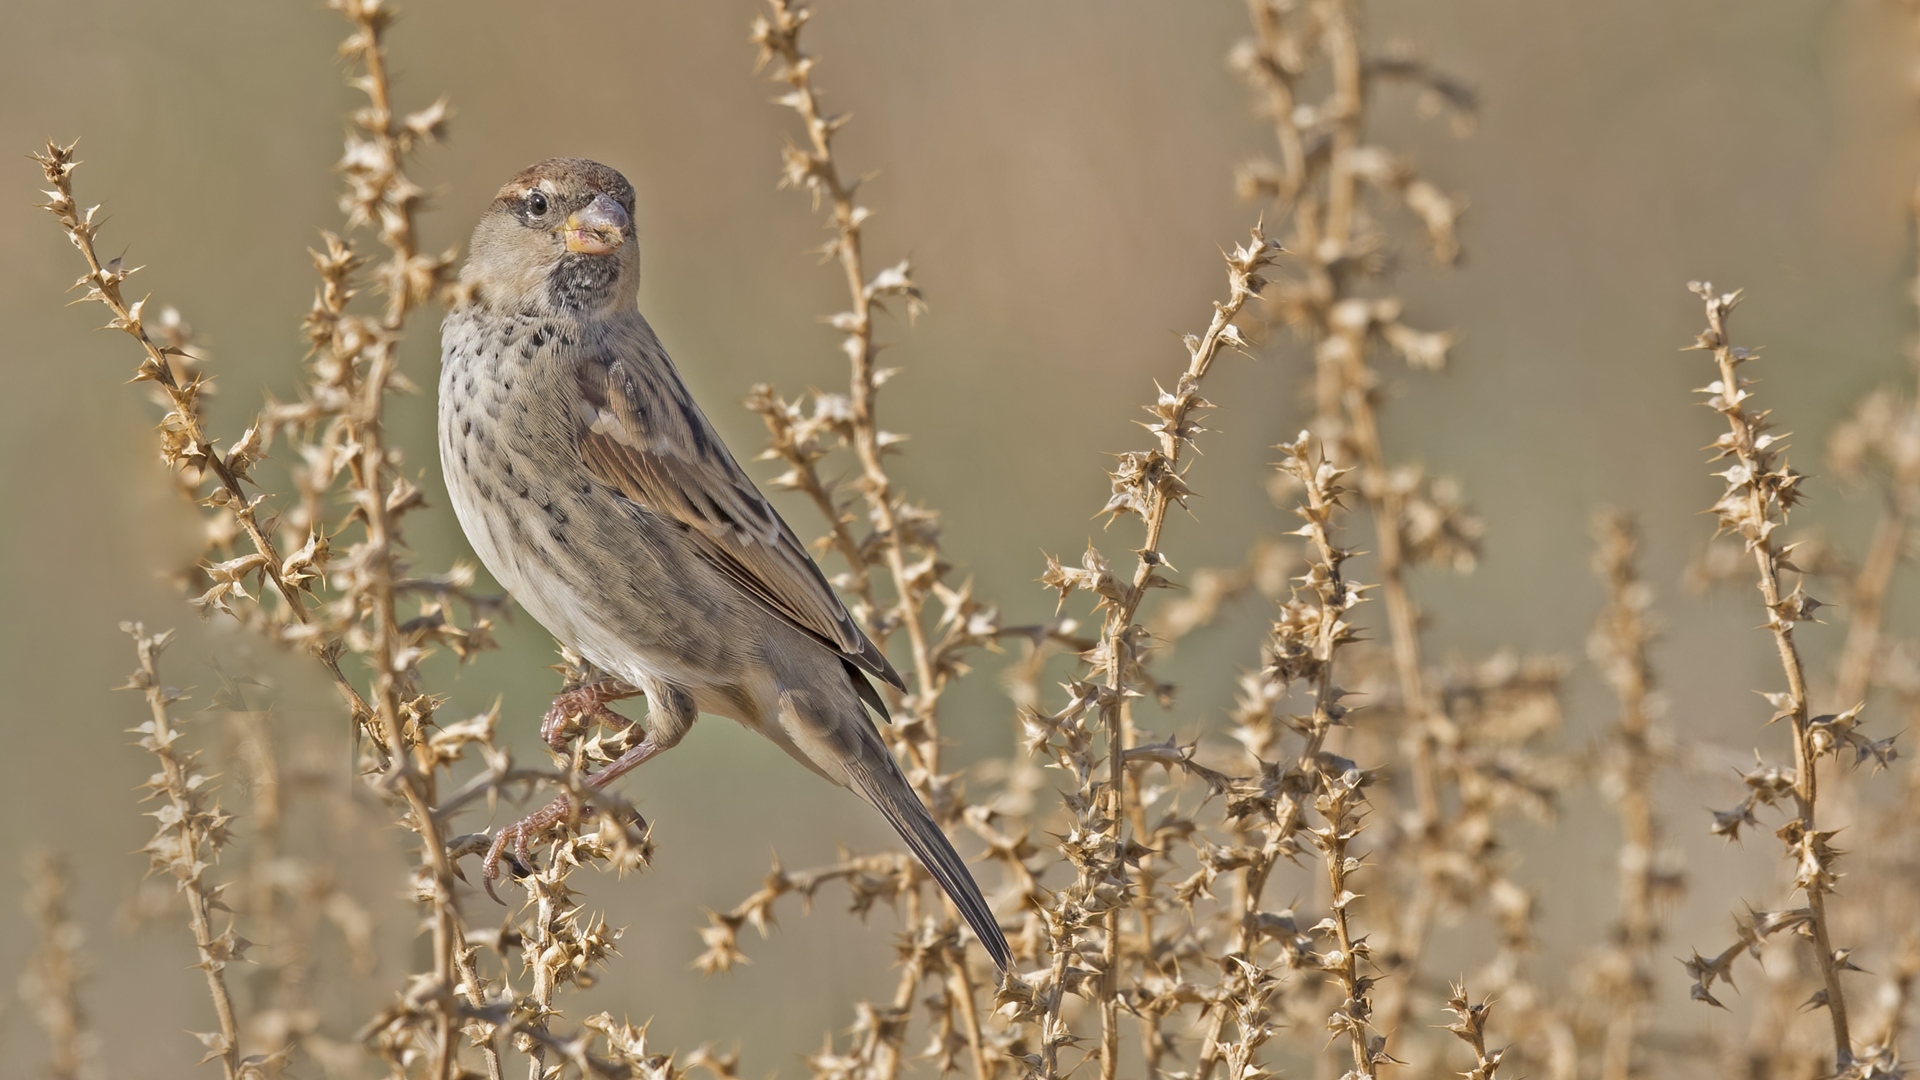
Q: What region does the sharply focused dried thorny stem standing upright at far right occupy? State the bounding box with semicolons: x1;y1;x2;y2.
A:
1693;282;1853;1068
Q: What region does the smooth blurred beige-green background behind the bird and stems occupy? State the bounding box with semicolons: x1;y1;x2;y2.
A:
0;0;1920;1076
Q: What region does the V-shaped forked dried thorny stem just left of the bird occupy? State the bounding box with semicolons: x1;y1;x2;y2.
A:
36;35;472;1078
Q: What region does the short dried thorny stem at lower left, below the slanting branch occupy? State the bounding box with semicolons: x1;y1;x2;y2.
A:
121;623;248;1080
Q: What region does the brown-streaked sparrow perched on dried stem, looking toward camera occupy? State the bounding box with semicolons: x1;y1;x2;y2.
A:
438;158;1012;970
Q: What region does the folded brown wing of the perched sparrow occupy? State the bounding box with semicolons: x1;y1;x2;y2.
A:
578;334;904;687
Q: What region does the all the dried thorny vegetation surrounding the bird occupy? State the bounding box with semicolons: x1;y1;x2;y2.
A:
25;0;1920;1080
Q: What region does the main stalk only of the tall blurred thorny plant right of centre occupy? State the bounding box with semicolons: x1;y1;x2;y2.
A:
1233;0;1498;1060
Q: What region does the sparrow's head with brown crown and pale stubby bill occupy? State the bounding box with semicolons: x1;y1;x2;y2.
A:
461;158;639;313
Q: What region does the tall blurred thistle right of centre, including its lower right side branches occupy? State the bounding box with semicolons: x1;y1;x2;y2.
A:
1231;0;1574;1076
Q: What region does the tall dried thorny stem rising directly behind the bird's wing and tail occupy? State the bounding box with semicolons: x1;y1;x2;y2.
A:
733;0;1002;1078
